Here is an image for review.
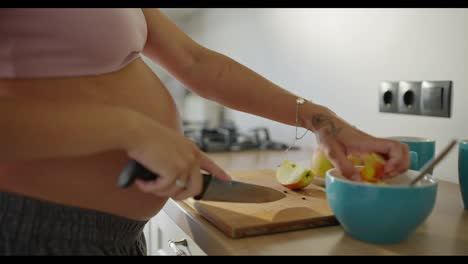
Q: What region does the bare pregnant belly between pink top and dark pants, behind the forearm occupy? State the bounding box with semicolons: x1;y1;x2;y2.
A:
0;59;185;220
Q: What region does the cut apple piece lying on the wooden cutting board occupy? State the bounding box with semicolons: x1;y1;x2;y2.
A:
276;160;314;190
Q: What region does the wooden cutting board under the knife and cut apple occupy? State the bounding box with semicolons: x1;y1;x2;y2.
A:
187;170;338;238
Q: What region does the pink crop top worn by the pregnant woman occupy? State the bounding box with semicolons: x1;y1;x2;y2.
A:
0;8;147;78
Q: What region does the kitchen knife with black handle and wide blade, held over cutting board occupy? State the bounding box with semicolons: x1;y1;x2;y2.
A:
118;160;286;203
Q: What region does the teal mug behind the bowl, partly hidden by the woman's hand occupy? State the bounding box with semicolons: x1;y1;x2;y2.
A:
388;137;435;173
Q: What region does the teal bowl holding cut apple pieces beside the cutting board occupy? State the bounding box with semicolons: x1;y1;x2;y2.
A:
325;169;438;244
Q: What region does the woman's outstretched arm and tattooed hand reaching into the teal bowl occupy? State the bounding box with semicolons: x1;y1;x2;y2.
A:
144;9;409;176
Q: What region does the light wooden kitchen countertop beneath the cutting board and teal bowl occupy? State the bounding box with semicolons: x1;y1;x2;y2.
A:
163;149;468;255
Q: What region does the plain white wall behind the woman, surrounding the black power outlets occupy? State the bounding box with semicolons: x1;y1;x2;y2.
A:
171;9;468;181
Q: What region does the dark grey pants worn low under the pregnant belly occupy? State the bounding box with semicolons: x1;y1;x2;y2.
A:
0;192;146;255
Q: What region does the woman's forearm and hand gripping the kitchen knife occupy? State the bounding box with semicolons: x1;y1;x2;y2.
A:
0;98;229;199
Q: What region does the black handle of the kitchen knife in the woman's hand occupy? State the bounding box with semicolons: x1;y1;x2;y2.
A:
117;160;212;200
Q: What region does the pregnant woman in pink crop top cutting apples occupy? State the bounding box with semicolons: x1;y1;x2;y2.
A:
0;8;409;255
